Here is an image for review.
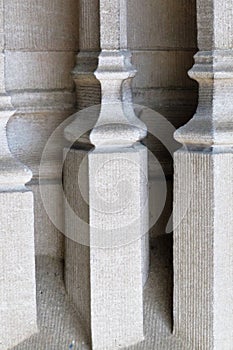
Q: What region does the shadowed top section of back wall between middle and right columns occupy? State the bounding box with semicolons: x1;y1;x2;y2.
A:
127;0;197;50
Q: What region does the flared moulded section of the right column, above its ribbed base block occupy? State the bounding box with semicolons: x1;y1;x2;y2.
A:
176;50;233;146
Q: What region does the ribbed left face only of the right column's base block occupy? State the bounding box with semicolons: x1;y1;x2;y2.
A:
174;151;214;350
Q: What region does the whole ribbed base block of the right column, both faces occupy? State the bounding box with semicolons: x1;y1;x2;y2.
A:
174;151;233;350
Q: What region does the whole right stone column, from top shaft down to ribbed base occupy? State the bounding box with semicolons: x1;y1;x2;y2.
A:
174;0;233;350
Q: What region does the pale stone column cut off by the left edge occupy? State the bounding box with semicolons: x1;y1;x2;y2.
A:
0;1;37;349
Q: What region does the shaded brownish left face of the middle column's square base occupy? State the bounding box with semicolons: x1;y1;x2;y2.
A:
63;149;91;342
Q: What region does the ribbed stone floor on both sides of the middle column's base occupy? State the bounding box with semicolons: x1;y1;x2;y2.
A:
12;235;196;350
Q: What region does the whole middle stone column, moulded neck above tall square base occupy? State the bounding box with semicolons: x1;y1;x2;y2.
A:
64;0;149;350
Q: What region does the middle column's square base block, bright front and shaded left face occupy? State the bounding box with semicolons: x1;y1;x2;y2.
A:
64;146;149;349
